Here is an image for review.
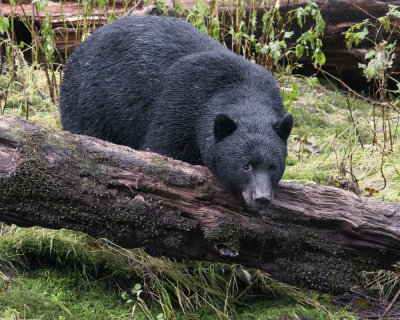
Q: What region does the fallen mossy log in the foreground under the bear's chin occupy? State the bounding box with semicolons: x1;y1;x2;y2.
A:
0;116;400;293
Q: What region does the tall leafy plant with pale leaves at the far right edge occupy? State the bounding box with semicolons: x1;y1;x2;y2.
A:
346;5;400;189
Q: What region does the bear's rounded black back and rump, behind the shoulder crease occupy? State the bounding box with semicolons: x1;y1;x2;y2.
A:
60;16;226;148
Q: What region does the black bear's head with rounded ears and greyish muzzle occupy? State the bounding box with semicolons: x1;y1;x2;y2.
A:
212;113;293;210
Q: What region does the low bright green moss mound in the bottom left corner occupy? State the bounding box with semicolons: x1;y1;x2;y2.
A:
0;269;147;320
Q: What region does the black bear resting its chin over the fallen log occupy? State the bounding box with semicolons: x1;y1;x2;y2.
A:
60;16;293;209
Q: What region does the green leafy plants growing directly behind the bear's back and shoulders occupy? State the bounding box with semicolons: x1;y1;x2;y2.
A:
183;0;326;74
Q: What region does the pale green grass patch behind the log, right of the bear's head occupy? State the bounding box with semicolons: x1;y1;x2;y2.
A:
283;78;400;201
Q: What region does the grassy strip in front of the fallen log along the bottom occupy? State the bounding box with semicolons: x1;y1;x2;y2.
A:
0;226;352;320
